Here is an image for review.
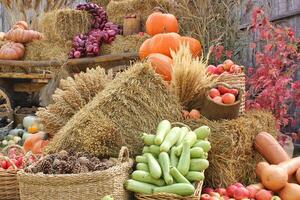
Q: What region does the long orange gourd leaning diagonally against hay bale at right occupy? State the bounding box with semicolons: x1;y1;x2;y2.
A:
254;132;290;164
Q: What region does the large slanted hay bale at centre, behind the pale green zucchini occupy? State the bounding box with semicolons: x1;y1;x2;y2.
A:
46;63;182;157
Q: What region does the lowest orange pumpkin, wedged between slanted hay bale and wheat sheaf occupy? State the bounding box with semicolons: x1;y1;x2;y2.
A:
148;53;173;81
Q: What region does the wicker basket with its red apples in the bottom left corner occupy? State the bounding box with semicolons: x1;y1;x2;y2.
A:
0;145;36;200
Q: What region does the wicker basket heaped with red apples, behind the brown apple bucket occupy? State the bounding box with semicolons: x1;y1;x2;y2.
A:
207;60;246;113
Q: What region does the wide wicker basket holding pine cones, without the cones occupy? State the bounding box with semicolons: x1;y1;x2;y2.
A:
18;147;133;200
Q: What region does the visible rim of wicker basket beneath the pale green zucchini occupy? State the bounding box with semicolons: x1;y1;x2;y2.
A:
135;182;203;200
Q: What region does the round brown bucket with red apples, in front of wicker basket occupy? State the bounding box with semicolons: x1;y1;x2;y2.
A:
201;83;243;120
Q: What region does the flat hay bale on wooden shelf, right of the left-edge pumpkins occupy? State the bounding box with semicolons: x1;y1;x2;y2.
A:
24;40;72;61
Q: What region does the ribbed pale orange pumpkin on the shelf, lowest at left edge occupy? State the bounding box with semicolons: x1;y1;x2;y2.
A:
0;42;25;60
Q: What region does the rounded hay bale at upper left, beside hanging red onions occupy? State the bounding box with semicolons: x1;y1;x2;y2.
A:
38;9;92;41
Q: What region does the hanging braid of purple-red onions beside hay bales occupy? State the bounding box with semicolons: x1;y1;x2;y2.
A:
69;3;121;58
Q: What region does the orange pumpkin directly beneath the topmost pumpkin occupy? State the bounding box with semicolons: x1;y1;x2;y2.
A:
149;33;180;57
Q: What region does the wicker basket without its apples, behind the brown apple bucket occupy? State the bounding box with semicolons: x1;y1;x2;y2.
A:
215;73;246;114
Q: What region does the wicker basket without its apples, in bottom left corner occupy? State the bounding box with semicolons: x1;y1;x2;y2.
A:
0;145;24;200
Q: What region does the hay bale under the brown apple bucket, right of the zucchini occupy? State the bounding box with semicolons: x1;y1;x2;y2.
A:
187;110;277;188
